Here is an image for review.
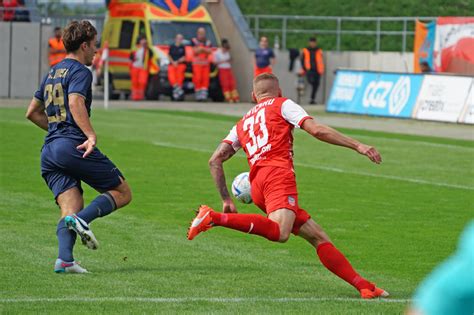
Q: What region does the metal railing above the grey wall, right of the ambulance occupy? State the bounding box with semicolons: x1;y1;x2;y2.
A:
245;14;436;52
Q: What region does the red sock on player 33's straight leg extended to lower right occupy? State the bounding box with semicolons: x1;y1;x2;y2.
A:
316;242;375;291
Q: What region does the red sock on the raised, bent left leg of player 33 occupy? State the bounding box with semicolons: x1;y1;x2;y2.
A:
211;211;280;242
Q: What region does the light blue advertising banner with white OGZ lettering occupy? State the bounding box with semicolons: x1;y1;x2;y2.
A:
326;70;423;118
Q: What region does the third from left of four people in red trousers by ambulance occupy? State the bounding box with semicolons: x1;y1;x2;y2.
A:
191;27;212;102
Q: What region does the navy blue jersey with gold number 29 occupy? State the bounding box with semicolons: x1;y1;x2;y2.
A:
34;58;92;143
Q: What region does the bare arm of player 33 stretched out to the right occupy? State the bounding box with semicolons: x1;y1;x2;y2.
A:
301;119;382;164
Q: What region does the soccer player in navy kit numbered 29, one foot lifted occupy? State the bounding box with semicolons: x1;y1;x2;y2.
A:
26;21;132;273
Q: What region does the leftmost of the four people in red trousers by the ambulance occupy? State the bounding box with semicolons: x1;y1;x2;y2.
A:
130;36;153;101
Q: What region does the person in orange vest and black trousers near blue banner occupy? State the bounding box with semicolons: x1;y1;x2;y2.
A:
301;37;324;104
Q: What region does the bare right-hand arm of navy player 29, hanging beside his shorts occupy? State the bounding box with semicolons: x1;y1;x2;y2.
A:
68;94;97;157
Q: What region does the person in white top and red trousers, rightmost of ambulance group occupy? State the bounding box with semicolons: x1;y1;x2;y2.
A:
214;39;239;103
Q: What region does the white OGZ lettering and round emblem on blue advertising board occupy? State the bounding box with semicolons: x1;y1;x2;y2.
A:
362;76;410;116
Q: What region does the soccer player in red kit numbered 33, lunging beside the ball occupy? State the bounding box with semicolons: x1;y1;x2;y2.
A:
188;73;389;299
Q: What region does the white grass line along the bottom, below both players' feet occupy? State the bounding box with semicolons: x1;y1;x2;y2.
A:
0;297;412;303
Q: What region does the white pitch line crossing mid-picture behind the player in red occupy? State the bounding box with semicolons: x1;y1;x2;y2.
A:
153;141;474;190
